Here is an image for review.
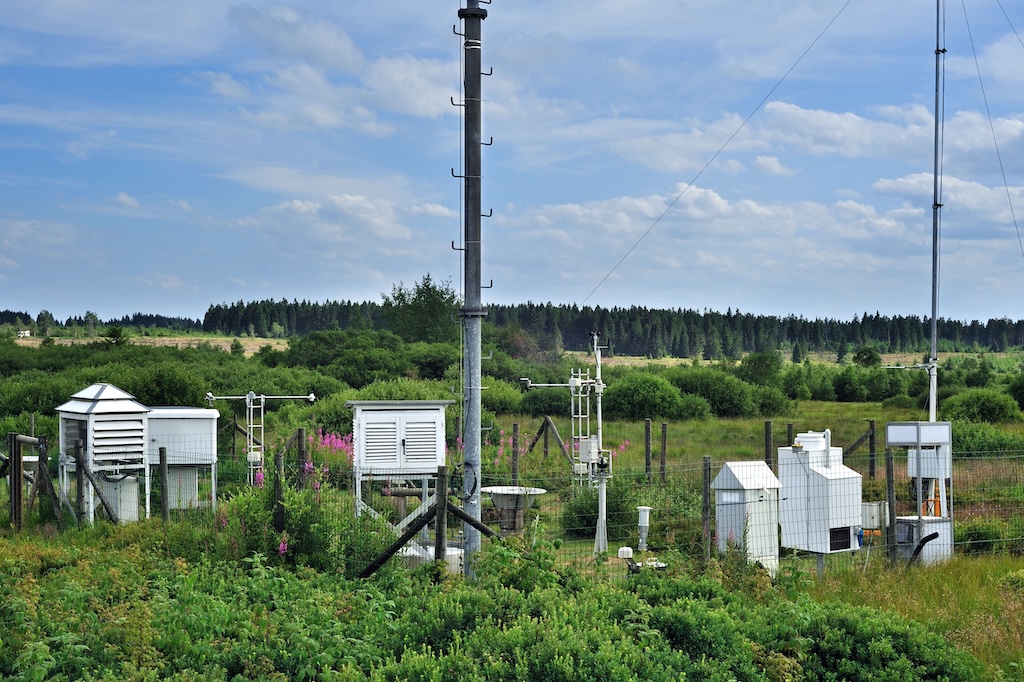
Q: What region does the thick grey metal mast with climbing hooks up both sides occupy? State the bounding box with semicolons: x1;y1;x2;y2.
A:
459;0;487;576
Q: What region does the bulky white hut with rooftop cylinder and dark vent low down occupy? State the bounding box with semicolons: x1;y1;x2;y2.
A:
778;429;862;554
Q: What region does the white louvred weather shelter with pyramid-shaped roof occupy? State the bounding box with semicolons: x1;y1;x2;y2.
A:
56;384;150;523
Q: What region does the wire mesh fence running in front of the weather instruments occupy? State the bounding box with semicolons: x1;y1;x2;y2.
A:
5;430;1024;568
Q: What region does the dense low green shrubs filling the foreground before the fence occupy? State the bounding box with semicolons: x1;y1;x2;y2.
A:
0;488;991;682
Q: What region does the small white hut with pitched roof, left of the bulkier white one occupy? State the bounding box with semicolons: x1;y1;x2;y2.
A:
711;461;780;576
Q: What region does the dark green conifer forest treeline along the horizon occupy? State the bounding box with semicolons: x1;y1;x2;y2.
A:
0;296;1024;359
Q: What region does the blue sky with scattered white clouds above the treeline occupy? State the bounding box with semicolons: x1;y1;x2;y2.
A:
0;0;1024;321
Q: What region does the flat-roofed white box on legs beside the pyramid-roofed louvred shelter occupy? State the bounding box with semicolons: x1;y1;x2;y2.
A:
146;407;220;509
